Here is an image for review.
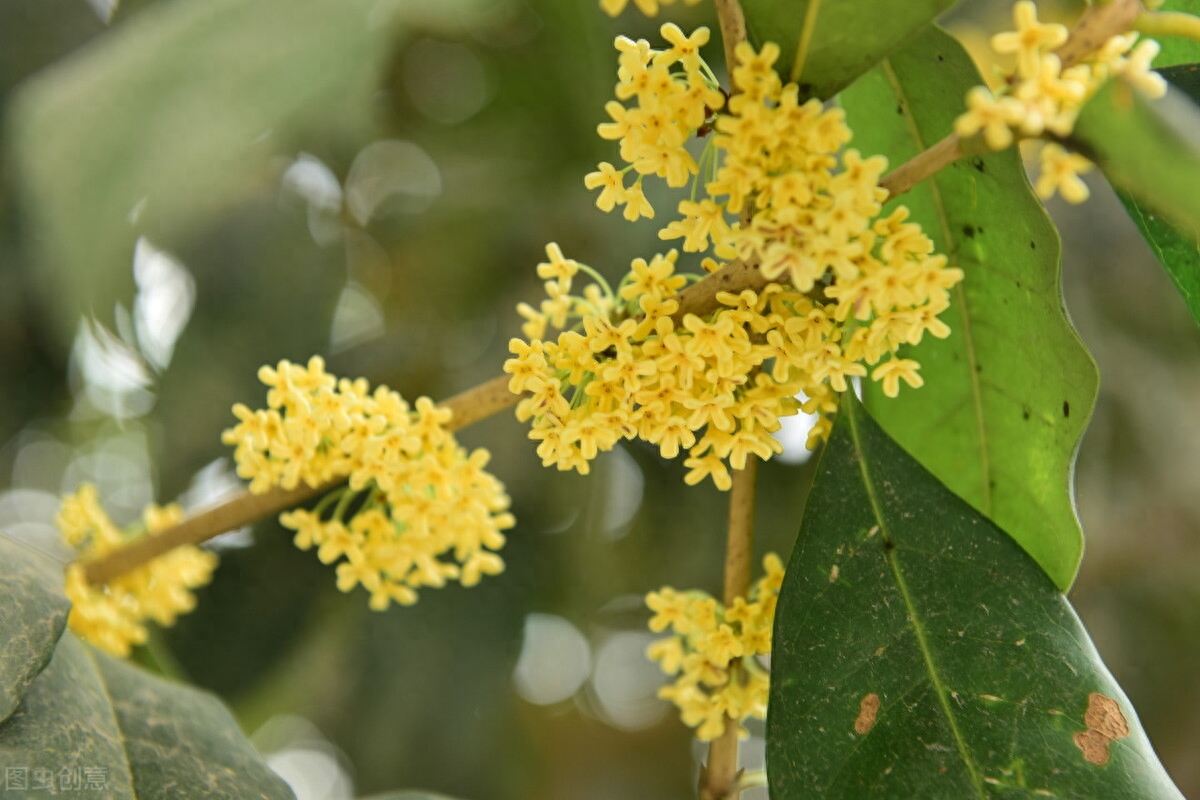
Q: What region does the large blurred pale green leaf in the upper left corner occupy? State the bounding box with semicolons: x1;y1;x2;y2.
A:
10;0;474;341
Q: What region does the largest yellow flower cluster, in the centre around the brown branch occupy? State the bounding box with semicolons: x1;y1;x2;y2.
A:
505;31;962;489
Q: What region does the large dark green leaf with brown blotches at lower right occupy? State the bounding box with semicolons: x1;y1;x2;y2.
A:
767;395;1182;800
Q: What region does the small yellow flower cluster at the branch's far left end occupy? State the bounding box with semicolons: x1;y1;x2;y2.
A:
54;483;217;656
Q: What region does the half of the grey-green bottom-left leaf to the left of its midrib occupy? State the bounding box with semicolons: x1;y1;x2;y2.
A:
0;633;135;799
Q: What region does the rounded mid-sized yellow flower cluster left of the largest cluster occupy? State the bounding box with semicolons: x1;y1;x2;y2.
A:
223;357;515;610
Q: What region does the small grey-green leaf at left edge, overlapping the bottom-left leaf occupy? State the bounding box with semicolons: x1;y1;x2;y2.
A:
0;536;71;721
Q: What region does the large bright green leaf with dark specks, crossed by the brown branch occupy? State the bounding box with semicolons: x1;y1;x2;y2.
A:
842;28;1099;590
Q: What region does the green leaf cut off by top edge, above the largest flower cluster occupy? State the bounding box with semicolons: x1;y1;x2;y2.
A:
742;0;956;100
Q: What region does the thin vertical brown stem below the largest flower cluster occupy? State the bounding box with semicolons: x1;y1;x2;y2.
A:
700;457;758;800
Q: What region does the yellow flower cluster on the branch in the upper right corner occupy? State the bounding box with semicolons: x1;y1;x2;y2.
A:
954;0;1166;203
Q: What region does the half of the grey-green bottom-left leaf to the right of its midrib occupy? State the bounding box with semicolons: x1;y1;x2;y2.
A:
96;652;293;800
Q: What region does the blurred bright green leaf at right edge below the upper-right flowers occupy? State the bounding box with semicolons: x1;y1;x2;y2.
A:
1073;79;1200;236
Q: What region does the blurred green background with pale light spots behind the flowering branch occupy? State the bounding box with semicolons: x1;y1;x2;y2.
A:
0;0;1200;800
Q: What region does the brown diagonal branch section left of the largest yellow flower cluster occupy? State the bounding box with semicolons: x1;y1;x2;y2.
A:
84;375;520;584
